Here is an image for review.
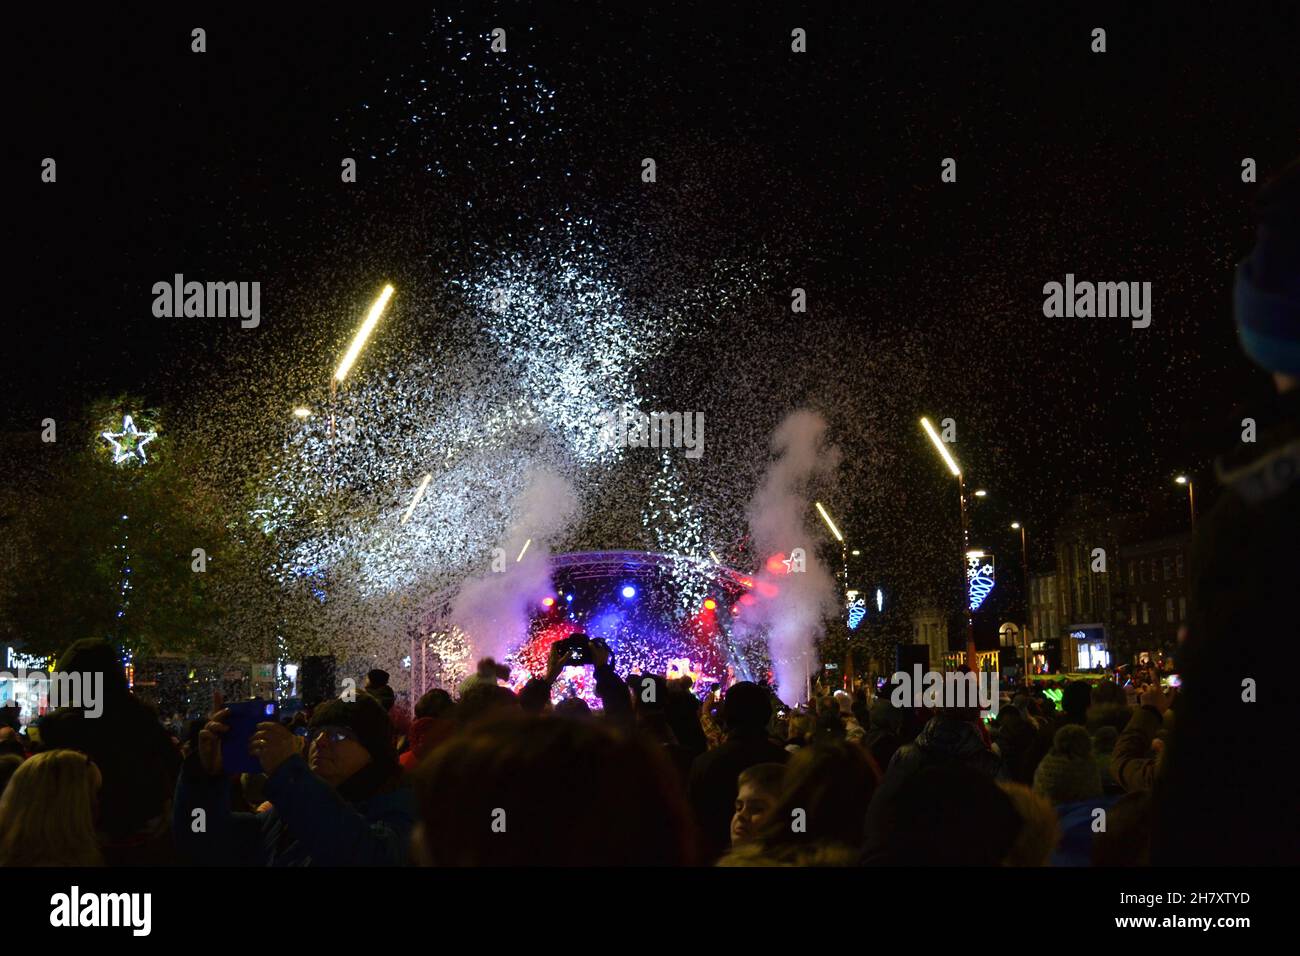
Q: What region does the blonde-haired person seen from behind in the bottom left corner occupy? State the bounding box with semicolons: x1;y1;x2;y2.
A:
0;750;104;866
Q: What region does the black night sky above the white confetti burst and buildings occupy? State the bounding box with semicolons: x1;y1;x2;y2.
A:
10;3;1300;598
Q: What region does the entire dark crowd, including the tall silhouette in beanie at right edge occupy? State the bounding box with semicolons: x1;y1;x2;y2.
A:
0;155;1300;866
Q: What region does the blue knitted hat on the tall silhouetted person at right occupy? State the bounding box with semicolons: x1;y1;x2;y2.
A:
1234;160;1300;376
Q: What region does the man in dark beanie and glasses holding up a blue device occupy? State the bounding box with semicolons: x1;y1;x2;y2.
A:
173;693;416;866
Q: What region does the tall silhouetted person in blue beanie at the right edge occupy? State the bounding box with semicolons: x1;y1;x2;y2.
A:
1154;159;1300;866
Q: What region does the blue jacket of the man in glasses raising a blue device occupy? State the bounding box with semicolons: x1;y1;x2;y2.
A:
172;754;416;866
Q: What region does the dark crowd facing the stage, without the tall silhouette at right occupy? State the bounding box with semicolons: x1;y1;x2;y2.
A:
0;629;1295;866
